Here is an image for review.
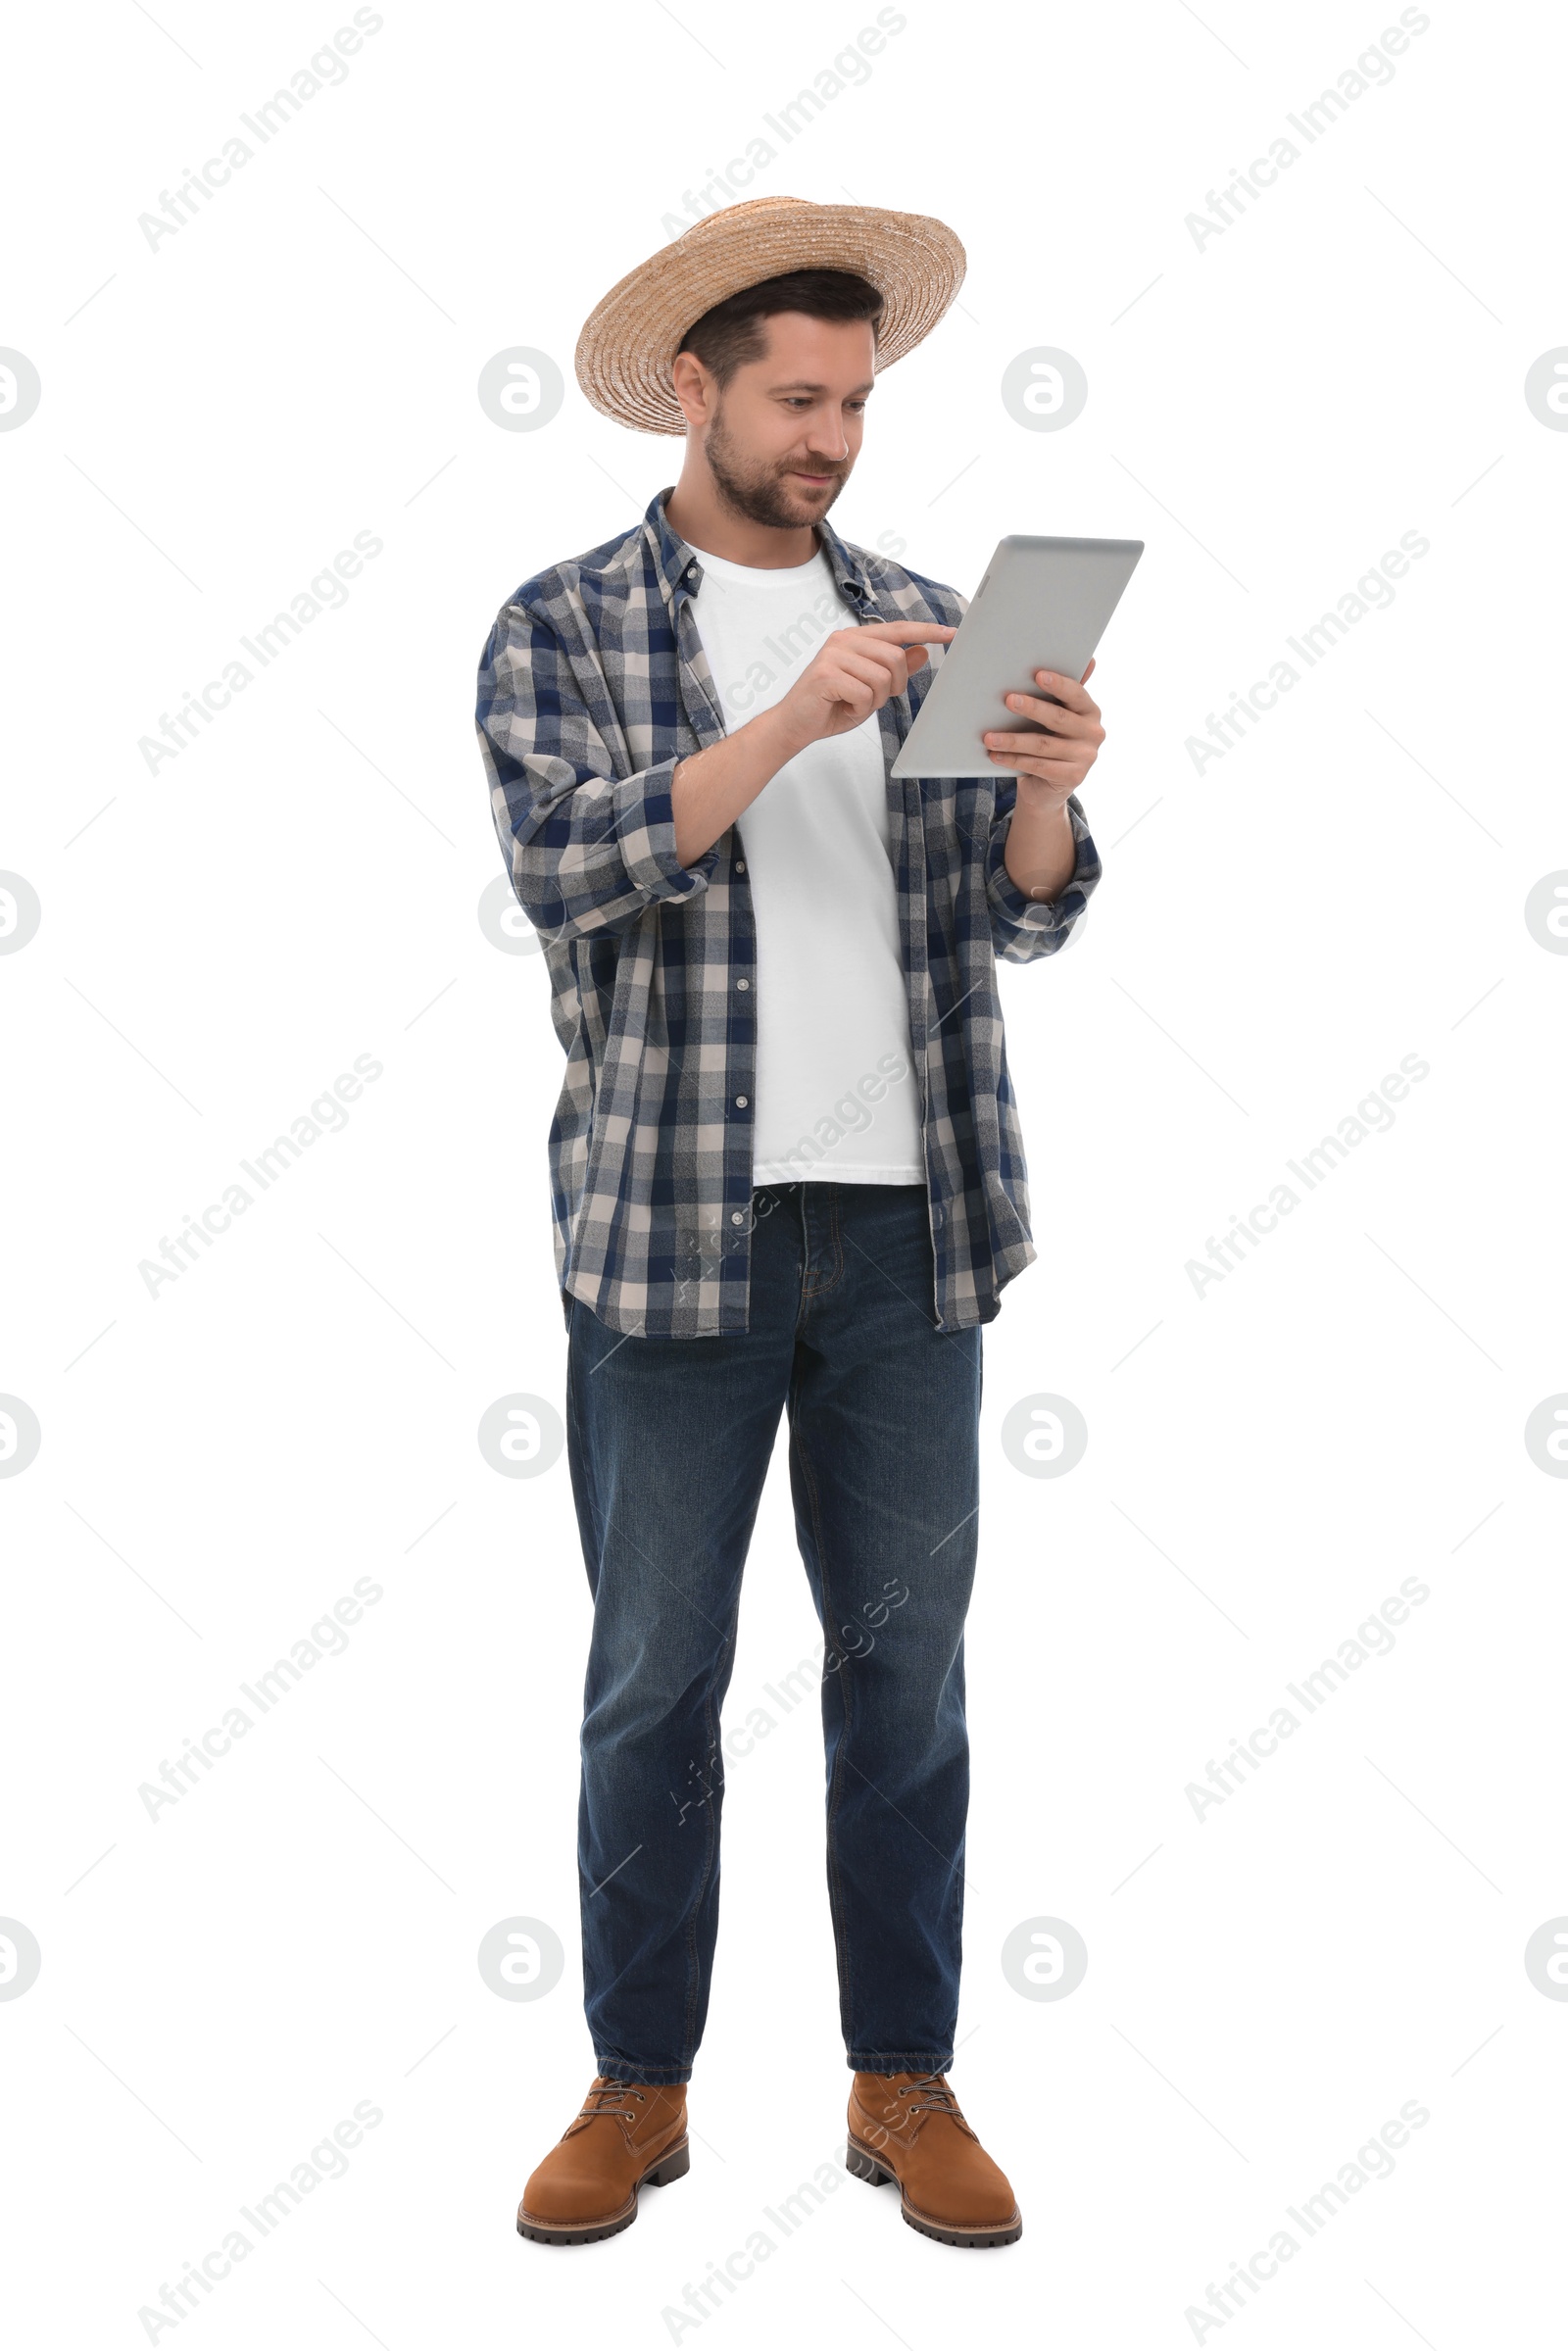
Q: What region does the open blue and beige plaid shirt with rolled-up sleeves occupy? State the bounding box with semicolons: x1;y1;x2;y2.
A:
477;491;1101;1338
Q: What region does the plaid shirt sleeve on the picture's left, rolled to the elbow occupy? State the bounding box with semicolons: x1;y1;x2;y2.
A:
477;605;719;941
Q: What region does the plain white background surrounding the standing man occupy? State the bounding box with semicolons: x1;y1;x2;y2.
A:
0;0;1568;2351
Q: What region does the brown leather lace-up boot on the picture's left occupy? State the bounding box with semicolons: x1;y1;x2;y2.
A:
517;2074;691;2245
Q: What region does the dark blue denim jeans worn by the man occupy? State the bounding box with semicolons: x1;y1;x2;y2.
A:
566;1180;980;2083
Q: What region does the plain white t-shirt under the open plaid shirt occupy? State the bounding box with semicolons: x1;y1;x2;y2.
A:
694;548;926;1185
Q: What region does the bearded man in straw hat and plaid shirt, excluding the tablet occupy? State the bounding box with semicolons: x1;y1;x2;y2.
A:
479;198;1104;2245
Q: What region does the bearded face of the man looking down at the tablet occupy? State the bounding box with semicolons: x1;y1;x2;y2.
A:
703;311;877;531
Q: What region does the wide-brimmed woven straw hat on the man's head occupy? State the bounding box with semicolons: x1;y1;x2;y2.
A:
576;195;964;432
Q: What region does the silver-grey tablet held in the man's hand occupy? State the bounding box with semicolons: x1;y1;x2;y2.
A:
891;536;1143;776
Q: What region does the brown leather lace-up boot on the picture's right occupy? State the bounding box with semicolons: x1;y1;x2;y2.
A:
847;2074;1022;2245
